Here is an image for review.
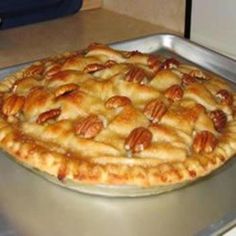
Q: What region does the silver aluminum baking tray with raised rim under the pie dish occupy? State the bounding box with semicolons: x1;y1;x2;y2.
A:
0;35;236;236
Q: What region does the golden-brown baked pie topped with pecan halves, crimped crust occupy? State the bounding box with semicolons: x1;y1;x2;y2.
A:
0;43;236;192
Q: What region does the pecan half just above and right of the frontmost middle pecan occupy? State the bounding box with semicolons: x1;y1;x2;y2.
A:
144;99;167;123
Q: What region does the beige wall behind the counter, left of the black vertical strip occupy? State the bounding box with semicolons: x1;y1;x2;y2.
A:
103;0;186;33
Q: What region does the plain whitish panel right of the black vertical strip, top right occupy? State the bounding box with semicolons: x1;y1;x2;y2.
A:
191;0;236;58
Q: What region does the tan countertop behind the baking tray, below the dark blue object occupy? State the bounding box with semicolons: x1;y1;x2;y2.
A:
0;9;177;68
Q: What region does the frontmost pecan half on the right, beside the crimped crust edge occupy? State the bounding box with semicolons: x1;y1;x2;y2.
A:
192;130;217;153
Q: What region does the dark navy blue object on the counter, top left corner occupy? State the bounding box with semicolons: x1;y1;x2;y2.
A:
0;0;82;29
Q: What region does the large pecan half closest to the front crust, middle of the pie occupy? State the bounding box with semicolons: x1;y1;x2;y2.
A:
124;127;152;153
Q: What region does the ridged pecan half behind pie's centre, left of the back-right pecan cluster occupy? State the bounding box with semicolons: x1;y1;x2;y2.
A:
125;67;148;84
